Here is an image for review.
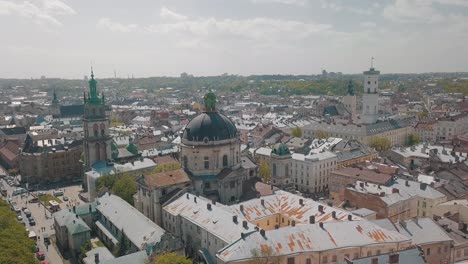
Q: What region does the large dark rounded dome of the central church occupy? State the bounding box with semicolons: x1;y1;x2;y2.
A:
182;111;237;142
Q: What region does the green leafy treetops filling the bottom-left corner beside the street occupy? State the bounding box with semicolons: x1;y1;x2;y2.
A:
0;199;39;264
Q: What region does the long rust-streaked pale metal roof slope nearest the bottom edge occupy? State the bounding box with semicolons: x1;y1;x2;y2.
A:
217;221;410;262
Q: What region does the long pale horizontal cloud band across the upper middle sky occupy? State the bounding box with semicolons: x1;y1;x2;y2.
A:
97;7;335;41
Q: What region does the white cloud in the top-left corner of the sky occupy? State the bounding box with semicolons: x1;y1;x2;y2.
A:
0;0;76;26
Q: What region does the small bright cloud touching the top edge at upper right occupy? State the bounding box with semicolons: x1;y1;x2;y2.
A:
383;0;444;24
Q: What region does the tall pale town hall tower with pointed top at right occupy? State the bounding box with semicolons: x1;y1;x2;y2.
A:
361;58;380;124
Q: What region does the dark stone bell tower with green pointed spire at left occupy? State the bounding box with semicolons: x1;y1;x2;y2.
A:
83;69;112;170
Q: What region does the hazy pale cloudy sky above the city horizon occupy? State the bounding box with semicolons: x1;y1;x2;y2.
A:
0;0;468;78
